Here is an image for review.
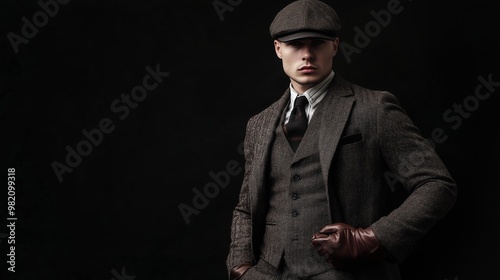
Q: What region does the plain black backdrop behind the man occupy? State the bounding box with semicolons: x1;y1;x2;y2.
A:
0;0;500;280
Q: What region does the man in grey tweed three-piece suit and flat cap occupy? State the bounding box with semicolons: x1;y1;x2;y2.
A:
227;0;456;280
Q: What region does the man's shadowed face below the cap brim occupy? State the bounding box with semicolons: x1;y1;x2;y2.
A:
274;38;339;93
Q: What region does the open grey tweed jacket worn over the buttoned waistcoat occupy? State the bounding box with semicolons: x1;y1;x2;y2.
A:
226;74;456;279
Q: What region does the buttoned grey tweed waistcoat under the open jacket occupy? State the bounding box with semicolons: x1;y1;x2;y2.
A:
261;94;331;277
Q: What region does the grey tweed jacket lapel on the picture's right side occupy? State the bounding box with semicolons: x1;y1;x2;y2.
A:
319;75;355;188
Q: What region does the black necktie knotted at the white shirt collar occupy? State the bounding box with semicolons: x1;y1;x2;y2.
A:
285;96;309;151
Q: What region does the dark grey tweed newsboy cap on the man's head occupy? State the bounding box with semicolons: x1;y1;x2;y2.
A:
269;0;340;42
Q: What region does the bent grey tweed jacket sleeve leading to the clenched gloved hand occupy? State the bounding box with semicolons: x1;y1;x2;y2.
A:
371;92;457;262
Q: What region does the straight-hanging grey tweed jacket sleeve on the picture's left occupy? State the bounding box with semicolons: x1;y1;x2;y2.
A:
226;118;255;275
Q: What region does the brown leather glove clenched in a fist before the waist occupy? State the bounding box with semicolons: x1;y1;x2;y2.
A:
312;223;383;268
